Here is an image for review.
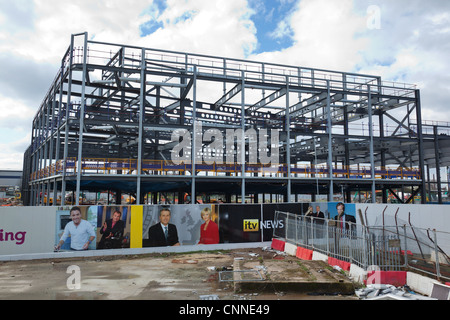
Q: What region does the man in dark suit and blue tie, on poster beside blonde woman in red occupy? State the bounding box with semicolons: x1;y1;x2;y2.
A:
148;208;180;247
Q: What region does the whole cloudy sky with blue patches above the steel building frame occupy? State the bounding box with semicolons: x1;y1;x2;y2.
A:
0;0;450;170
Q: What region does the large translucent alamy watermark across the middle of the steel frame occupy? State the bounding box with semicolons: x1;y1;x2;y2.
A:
171;122;280;165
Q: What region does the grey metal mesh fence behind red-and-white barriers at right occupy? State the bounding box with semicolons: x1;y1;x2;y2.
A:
273;211;450;279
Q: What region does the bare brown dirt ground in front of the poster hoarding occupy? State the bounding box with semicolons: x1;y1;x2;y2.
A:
0;248;357;300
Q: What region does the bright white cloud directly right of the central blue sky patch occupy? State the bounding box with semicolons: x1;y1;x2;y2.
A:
250;0;367;71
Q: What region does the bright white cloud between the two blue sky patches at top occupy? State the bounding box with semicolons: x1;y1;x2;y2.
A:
139;0;257;58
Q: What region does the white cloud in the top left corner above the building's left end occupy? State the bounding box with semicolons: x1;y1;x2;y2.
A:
0;0;151;63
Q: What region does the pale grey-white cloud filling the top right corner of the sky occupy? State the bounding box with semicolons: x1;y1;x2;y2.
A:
358;0;450;121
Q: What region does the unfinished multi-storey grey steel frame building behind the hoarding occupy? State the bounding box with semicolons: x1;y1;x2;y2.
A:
23;33;450;205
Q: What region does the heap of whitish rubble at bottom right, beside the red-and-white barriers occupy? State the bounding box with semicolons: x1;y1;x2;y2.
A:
355;284;436;300
